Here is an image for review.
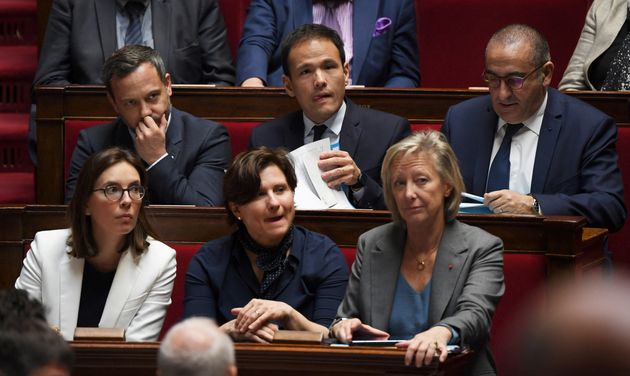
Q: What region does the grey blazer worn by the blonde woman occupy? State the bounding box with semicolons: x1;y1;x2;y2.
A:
337;220;505;375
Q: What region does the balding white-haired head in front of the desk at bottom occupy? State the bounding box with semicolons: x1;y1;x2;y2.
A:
157;317;236;376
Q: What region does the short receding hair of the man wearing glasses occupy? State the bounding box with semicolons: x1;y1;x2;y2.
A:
486;24;551;67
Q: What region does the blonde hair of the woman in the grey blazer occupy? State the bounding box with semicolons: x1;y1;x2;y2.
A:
381;131;464;224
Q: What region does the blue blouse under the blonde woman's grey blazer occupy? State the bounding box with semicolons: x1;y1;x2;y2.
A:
389;273;431;340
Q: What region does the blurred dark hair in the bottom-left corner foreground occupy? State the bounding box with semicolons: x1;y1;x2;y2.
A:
0;288;74;376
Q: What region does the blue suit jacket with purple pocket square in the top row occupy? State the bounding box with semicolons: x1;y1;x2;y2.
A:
236;0;420;87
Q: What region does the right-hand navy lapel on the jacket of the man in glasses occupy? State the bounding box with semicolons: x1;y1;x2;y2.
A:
530;89;563;193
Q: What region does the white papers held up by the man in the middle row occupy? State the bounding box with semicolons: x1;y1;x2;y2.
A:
289;138;354;210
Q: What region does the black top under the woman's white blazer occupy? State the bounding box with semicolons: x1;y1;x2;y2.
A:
77;261;116;327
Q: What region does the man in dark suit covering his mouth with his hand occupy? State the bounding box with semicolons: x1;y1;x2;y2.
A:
66;45;230;206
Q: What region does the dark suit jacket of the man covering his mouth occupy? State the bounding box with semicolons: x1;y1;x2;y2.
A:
66;108;231;206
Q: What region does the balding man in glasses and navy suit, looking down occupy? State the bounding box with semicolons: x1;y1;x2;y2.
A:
442;25;626;231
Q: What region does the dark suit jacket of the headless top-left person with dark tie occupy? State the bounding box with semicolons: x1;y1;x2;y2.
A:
35;0;234;85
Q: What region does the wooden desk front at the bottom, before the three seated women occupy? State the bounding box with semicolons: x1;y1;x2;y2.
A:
71;342;471;376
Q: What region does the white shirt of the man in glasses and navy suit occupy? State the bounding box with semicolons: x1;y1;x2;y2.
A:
488;93;548;194
